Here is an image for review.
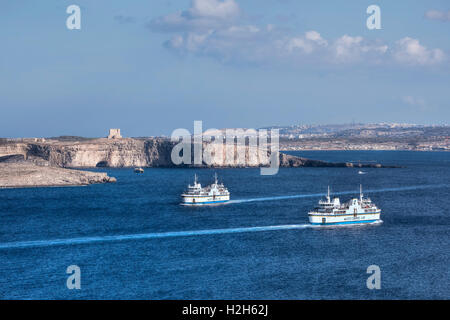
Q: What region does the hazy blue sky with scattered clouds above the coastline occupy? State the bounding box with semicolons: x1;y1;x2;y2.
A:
0;0;450;137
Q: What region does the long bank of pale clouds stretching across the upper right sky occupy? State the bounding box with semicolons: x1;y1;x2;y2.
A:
148;0;446;66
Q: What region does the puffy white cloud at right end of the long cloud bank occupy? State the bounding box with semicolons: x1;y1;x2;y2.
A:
393;37;445;65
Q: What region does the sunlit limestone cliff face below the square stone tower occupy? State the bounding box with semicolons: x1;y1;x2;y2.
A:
0;138;394;168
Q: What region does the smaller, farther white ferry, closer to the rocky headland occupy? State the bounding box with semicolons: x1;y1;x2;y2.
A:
181;174;230;205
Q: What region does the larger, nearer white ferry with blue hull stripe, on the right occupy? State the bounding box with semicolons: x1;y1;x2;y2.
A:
308;186;381;225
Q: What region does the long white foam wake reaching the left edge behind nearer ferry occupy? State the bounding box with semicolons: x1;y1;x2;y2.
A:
0;224;313;250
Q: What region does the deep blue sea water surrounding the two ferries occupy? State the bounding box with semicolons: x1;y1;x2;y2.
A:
0;151;450;299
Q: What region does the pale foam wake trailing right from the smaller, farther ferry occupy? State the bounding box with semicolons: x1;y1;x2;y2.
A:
227;184;449;204
